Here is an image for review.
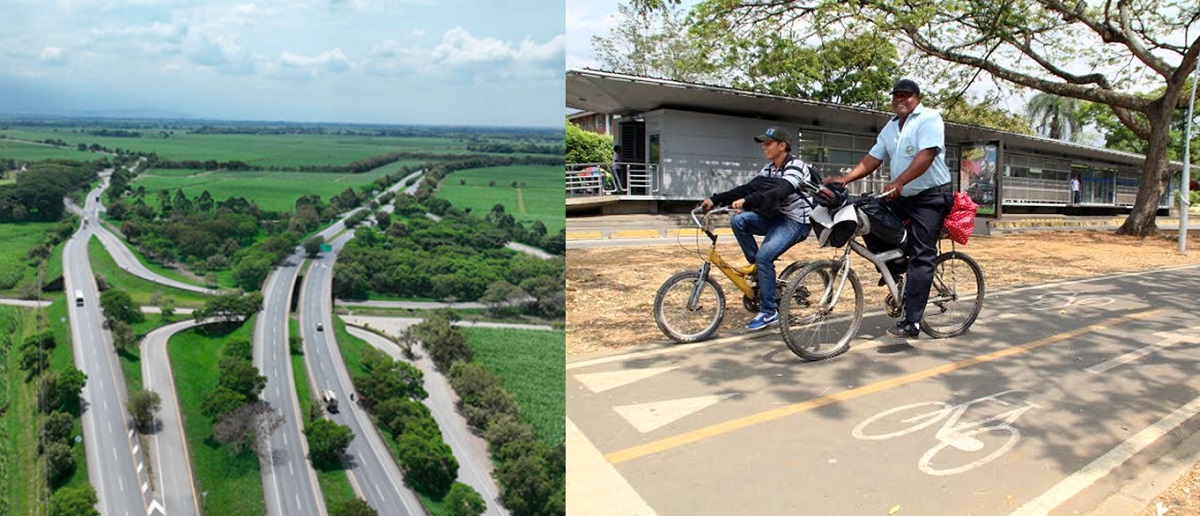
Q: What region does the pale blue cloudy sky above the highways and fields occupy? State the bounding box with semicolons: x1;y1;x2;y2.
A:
0;0;566;127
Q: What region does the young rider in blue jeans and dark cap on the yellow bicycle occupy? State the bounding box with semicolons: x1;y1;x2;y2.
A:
701;127;814;330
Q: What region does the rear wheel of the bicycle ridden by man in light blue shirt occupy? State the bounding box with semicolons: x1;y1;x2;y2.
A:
920;251;984;338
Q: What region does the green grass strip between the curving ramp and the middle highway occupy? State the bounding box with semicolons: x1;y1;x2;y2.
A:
168;318;266;515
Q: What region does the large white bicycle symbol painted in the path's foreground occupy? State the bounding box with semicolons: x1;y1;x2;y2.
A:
851;390;1039;476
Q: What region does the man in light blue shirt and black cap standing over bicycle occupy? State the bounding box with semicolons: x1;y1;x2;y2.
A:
824;79;953;338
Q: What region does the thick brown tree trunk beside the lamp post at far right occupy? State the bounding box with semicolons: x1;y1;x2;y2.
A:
1117;107;1171;236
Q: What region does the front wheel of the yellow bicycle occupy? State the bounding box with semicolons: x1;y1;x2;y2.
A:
654;271;725;342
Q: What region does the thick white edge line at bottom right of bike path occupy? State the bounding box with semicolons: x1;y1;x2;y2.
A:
1017;397;1200;516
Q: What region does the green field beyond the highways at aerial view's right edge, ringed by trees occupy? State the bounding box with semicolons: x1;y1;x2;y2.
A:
437;166;566;234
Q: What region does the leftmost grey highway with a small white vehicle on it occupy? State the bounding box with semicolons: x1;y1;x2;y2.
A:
62;190;163;516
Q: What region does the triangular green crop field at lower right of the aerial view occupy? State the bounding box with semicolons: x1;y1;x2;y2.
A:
460;328;566;445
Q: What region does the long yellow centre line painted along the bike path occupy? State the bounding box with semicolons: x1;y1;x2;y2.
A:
605;308;1164;464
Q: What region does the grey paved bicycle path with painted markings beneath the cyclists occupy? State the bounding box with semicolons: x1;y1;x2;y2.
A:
566;268;1200;514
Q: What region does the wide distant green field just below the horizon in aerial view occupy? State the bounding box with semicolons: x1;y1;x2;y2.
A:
0;127;467;168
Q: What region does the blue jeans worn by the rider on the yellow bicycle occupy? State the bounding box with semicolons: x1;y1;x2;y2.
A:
731;211;809;313
